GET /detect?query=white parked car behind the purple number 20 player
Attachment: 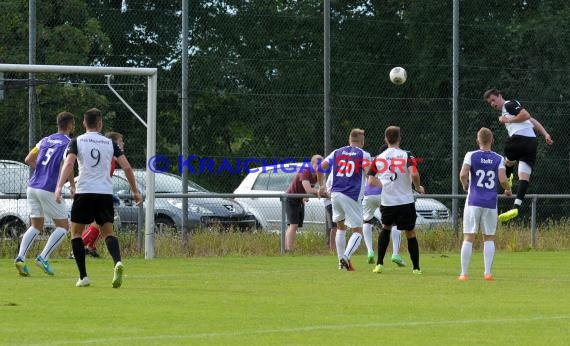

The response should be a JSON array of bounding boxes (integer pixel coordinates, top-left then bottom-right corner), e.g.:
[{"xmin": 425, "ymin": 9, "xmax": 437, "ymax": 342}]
[{"xmin": 234, "ymin": 163, "xmax": 451, "ymax": 231}]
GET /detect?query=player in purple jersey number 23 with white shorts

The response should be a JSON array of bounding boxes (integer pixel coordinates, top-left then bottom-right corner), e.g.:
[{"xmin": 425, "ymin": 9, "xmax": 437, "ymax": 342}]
[{"xmin": 459, "ymin": 127, "xmax": 512, "ymax": 281}]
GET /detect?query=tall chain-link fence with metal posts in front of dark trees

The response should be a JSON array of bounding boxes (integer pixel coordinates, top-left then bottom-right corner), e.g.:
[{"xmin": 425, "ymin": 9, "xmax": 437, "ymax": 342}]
[{"xmin": 0, "ymin": 0, "xmax": 570, "ymax": 238}]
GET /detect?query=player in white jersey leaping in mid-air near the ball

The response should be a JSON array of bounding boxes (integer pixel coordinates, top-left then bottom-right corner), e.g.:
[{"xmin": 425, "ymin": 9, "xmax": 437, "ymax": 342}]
[{"xmin": 483, "ymin": 89, "xmax": 554, "ymax": 221}]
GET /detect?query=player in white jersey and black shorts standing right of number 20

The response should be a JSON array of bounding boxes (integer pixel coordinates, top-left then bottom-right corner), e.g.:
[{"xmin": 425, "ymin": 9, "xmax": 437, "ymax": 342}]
[{"xmin": 368, "ymin": 126, "xmax": 425, "ymax": 274}]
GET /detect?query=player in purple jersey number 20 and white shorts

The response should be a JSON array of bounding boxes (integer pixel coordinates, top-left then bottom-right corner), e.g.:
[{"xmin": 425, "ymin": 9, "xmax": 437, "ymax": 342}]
[{"xmin": 321, "ymin": 129, "xmax": 370, "ymax": 271}]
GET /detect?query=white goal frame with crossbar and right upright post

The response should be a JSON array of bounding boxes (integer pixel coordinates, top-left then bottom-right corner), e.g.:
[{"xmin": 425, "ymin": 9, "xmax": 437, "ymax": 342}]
[{"xmin": 0, "ymin": 64, "xmax": 158, "ymax": 259}]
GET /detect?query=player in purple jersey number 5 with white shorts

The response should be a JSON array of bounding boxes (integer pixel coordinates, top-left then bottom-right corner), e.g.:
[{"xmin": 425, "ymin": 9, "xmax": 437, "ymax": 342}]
[{"xmin": 15, "ymin": 112, "xmax": 75, "ymax": 276}]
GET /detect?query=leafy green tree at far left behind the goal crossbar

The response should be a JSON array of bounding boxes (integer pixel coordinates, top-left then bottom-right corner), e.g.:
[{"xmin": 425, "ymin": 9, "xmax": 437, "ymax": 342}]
[{"xmin": 0, "ymin": 0, "xmax": 109, "ymax": 157}]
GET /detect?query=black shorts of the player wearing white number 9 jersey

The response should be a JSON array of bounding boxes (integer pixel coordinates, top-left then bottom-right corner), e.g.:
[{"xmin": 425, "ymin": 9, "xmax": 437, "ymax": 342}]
[{"xmin": 71, "ymin": 193, "xmax": 114, "ymax": 225}]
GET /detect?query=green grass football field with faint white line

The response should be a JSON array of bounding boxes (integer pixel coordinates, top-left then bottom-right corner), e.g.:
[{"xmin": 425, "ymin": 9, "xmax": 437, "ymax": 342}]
[{"xmin": 0, "ymin": 251, "xmax": 570, "ymax": 345}]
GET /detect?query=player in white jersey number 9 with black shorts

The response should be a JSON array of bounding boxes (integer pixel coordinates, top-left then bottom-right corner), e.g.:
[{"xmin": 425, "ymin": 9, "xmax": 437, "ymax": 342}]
[{"xmin": 55, "ymin": 108, "xmax": 142, "ymax": 288}]
